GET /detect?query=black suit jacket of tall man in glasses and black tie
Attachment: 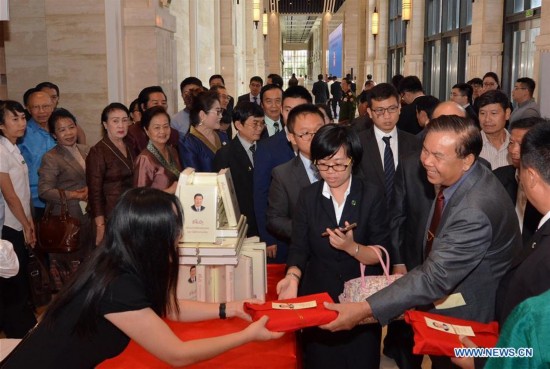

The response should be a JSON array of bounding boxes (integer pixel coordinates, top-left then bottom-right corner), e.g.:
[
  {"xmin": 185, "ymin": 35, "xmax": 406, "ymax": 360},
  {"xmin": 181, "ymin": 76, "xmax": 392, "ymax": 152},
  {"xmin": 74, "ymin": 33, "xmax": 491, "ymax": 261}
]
[{"xmin": 359, "ymin": 127, "xmax": 421, "ymax": 201}]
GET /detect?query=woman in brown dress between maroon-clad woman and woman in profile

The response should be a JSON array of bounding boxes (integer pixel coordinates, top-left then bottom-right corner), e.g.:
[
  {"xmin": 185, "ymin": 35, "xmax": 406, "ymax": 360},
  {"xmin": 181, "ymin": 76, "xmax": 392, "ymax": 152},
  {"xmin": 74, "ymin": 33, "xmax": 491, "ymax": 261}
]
[{"xmin": 134, "ymin": 106, "xmax": 182, "ymax": 194}]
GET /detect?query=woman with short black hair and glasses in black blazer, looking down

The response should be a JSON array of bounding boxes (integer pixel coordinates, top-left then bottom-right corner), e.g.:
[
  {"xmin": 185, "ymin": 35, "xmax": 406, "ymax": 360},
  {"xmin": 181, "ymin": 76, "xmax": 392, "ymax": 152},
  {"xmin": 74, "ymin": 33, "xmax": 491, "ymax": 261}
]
[{"xmin": 277, "ymin": 124, "xmax": 389, "ymax": 369}]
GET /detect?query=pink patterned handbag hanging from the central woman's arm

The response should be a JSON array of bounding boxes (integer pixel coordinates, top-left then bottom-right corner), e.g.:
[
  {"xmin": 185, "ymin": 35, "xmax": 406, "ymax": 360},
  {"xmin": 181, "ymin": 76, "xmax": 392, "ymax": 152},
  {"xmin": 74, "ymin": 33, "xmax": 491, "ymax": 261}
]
[{"xmin": 338, "ymin": 245, "xmax": 403, "ymax": 323}]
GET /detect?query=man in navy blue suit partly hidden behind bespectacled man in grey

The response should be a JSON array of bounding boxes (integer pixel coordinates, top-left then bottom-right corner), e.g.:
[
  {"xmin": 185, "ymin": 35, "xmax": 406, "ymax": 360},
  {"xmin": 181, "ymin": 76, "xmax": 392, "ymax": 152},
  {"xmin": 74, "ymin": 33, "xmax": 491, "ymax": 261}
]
[{"xmin": 253, "ymin": 86, "xmax": 313, "ymax": 263}]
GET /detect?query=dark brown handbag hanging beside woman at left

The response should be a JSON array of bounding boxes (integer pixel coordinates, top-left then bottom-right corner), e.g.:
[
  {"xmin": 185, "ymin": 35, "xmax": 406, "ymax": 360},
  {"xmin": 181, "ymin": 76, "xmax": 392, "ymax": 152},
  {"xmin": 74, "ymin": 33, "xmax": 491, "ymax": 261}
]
[{"xmin": 37, "ymin": 190, "xmax": 80, "ymax": 253}]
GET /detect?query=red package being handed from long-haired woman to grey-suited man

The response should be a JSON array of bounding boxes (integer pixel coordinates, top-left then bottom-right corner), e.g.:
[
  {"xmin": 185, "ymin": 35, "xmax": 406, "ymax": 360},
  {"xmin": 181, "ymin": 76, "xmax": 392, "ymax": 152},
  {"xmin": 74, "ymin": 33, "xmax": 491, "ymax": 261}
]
[{"xmin": 244, "ymin": 292, "xmax": 338, "ymax": 332}]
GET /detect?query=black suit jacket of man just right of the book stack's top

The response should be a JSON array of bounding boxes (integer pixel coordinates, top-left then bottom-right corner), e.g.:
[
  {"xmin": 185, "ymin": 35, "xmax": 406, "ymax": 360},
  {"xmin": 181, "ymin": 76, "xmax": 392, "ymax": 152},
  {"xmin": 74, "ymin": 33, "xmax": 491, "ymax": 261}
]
[{"xmin": 213, "ymin": 136, "xmax": 258, "ymax": 237}]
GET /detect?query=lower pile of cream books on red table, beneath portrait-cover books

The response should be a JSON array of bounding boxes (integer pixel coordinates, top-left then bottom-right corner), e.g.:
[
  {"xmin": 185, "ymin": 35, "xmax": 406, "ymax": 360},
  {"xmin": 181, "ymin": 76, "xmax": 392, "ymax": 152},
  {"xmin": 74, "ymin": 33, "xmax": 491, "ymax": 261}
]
[{"xmin": 177, "ymin": 237, "xmax": 267, "ymax": 302}]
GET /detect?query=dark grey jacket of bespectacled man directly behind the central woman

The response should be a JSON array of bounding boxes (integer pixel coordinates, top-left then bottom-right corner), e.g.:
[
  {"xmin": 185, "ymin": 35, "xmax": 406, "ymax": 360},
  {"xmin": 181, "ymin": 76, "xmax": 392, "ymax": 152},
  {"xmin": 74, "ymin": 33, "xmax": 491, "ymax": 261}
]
[{"xmin": 267, "ymin": 155, "xmax": 311, "ymax": 243}]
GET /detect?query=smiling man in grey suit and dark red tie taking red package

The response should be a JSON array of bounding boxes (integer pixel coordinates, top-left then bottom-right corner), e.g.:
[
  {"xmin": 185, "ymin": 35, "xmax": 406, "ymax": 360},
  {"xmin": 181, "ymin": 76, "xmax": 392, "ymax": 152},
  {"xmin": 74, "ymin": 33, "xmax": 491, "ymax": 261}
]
[{"xmin": 324, "ymin": 116, "xmax": 521, "ymax": 367}]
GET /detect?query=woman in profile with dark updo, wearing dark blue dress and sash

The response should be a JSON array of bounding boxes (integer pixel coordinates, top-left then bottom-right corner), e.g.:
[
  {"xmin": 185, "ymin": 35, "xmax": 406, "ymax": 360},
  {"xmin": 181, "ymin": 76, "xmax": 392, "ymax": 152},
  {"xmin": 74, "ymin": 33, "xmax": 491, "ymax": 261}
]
[{"xmin": 180, "ymin": 91, "xmax": 229, "ymax": 172}]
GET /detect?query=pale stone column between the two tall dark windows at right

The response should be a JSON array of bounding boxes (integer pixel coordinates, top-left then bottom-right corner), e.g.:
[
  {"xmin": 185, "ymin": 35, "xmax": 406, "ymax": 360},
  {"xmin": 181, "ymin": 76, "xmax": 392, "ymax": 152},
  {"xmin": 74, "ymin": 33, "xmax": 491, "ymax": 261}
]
[{"xmin": 466, "ymin": 0, "xmax": 504, "ymax": 80}]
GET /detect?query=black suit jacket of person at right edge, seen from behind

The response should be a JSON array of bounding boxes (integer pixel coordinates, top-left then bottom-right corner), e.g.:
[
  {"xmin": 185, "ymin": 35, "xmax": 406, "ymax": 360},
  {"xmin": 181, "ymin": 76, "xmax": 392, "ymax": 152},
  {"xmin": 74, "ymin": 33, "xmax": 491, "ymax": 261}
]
[{"xmin": 496, "ymin": 217, "xmax": 550, "ymax": 324}]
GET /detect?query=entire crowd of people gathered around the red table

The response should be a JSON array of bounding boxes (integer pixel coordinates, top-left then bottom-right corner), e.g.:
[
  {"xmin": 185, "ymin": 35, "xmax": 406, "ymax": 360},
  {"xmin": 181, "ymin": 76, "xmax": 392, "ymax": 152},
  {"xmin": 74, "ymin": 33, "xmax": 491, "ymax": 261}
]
[{"xmin": 0, "ymin": 68, "xmax": 550, "ymax": 369}]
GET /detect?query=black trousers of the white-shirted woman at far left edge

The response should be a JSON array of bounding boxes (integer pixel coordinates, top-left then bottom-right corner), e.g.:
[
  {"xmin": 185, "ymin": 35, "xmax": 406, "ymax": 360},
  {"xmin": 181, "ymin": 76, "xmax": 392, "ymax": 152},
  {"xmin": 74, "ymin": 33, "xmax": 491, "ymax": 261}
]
[{"xmin": 0, "ymin": 226, "xmax": 36, "ymax": 338}]
